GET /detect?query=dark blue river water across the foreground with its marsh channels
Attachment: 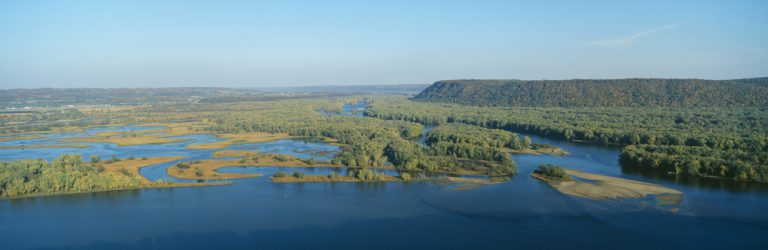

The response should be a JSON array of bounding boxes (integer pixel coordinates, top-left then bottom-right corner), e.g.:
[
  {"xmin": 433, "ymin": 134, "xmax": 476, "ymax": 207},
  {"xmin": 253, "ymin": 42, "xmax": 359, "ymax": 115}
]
[{"xmin": 0, "ymin": 126, "xmax": 768, "ymax": 249}]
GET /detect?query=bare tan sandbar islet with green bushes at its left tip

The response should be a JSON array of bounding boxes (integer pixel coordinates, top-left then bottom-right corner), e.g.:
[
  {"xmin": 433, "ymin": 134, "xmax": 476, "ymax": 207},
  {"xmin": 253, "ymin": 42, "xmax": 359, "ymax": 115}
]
[{"xmin": 532, "ymin": 170, "xmax": 683, "ymax": 201}]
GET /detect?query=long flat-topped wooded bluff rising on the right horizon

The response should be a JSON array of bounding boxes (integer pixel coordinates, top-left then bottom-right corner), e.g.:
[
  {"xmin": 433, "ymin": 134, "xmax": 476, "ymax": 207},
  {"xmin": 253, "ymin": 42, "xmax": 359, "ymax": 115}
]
[{"xmin": 413, "ymin": 77, "xmax": 768, "ymax": 107}]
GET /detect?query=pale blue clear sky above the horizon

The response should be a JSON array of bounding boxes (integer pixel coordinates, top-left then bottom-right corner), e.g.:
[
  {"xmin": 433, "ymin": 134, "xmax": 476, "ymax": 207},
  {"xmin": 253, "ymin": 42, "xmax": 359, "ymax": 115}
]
[{"xmin": 0, "ymin": 0, "xmax": 768, "ymax": 89}]
